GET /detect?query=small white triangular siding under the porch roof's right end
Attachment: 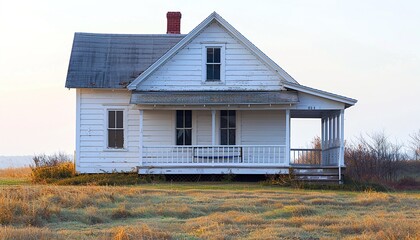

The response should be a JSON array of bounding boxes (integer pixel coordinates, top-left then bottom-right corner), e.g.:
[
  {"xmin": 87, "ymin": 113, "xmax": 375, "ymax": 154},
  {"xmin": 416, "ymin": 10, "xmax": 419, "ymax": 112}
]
[{"xmin": 296, "ymin": 92, "xmax": 344, "ymax": 109}]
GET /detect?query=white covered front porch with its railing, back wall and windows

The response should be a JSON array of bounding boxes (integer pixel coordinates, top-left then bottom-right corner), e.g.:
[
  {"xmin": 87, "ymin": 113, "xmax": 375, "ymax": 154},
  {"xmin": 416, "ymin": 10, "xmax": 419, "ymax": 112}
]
[{"xmin": 132, "ymin": 91, "xmax": 344, "ymax": 180}]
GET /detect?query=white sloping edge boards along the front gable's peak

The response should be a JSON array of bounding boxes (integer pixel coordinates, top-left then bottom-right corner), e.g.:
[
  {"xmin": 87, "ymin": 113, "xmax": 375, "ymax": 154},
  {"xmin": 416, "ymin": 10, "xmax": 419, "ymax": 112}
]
[{"xmin": 127, "ymin": 12, "xmax": 297, "ymax": 90}]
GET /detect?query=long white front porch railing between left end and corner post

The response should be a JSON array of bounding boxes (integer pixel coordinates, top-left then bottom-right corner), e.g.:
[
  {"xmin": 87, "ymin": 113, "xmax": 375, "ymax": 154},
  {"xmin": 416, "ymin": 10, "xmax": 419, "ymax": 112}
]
[{"xmin": 142, "ymin": 145, "xmax": 289, "ymax": 166}]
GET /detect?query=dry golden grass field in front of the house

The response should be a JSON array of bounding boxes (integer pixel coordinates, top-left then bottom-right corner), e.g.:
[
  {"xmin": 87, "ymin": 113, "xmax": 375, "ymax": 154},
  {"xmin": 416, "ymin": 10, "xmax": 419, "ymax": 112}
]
[{"xmin": 0, "ymin": 183, "xmax": 420, "ymax": 239}]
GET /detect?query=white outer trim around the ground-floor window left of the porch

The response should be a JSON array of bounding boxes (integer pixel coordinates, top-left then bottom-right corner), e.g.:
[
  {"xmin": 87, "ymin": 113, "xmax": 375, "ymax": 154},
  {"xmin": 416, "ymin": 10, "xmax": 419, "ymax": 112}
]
[{"xmin": 103, "ymin": 106, "xmax": 128, "ymax": 152}]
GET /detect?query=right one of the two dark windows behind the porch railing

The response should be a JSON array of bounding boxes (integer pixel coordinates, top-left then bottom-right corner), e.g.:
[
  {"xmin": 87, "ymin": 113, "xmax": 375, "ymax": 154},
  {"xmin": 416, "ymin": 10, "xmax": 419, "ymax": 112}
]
[{"xmin": 220, "ymin": 110, "xmax": 236, "ymax": 145}]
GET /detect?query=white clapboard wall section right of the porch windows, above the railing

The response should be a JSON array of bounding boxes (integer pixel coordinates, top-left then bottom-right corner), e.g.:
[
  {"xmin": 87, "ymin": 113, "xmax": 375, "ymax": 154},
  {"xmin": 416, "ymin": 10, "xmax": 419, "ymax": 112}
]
[{"xmin": 241, "ymin": 110, "xmax": 286, "ymax": 145}]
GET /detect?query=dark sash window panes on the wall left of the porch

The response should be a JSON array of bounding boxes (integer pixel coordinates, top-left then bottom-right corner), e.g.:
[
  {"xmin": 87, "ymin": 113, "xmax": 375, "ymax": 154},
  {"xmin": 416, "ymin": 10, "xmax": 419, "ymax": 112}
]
[{"xmin": 108, "ymin": 110, "xmax": 124, "ymax": 149}]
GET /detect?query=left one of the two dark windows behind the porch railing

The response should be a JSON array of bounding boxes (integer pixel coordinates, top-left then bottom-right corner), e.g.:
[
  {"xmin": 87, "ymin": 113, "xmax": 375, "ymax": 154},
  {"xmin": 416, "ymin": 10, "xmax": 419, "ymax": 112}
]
[{"xmin": 176, "ymin": 110, "xmax": 192, "ymax": 145}]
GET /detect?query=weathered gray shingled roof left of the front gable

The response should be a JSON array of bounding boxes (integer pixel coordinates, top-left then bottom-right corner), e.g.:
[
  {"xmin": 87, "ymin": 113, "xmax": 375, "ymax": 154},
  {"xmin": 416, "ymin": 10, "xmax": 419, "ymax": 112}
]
[{"xmin": 66, "ymin": 33, "xmax": 185, "ymax": 88}]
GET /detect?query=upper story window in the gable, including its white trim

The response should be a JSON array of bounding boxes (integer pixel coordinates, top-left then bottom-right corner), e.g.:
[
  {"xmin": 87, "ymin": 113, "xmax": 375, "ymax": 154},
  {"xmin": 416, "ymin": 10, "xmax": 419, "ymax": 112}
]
[{"xmin": 202, "ymin": 44, "xmax": 225, "ymax": 84}]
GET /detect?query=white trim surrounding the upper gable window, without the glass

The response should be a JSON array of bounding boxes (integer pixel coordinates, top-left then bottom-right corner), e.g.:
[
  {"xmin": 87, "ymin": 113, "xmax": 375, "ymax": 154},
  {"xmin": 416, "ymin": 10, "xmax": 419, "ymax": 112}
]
[{"xmin": 201, "ymin": 43, "xmax": 226, "ymax": 85}]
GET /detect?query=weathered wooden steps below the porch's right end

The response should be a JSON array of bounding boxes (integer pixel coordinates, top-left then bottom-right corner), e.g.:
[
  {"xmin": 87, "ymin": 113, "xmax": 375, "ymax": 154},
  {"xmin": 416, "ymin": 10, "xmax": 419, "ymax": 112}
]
[{"xmin": 291, "ymin": 165, "xmax": 344, "ymax": 184}]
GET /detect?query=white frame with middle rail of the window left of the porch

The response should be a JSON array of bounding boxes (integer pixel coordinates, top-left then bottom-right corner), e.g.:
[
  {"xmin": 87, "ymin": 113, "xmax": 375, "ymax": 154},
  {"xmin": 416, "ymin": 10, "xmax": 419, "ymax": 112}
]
[{"xmin": 104, "ymin": 107, "xmax": 128, "ymax": 152}]
